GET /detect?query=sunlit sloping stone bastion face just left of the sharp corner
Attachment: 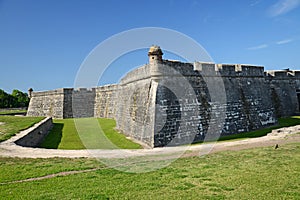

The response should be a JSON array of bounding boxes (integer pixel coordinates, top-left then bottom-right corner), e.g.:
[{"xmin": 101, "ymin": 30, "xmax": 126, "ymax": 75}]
[{"xmin": 116, "ymin": 65, "xmax": 157, "ymax": 147}]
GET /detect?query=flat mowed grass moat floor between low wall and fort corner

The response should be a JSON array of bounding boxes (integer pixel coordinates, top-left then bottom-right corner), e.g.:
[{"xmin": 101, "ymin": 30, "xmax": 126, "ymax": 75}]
[{"xmin": 40, "ymin": 118, "xmax": 142, "ymax": 149}]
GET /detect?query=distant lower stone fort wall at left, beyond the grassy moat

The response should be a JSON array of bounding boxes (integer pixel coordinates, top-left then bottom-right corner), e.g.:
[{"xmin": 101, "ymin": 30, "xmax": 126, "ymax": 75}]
[{"xmin": 27, "ymin": 85, "xmax": 118, "ymax": 118}]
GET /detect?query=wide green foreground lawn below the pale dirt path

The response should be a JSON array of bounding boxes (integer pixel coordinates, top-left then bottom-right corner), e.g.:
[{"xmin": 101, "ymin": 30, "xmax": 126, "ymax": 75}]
[{"xmin": 0, "ymin": 143, "xmax": 300, "ymax": 199}]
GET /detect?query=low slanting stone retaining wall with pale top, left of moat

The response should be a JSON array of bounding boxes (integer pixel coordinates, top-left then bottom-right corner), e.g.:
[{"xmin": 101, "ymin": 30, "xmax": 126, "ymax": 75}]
[{"xmin": 14, "ymin": 117, "xmax": 53, "ymax": 147}]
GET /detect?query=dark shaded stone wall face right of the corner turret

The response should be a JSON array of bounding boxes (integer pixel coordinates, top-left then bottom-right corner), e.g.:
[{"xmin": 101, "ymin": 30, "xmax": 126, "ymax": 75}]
[{"xmin": 154, "ymin": 61, "xmax": 276, "ymax": 147}]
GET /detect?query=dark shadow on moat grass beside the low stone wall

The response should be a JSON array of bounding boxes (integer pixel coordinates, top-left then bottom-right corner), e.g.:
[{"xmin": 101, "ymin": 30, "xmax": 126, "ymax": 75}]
[{"xmin": 39, "ymin": 123, "xmax": 64, "ymax": 149}]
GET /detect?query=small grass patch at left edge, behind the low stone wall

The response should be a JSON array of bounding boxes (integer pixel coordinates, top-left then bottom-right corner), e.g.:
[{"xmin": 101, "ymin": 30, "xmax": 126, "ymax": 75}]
[{"xmin": 0, "ymin": 115, "xmax": 44, "ymax": 142}]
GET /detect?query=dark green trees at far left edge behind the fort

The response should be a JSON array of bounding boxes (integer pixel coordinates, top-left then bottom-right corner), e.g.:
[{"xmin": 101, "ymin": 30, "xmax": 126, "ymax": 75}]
[{"xmin": 0, "ymin": 89, "xmax": 29, "ymax": 108}]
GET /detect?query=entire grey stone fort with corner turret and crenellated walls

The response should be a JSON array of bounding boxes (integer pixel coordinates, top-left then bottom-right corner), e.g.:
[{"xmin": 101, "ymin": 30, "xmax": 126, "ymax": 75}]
[{"xmin": 27, "ymin": 46, "xmax": 300, "ymax": 147}]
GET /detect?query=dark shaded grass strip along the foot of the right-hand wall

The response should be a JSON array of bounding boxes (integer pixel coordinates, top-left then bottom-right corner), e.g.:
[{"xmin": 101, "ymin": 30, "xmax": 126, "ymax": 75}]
[{"xmin": 194, "ymin": 116, "xmax": 300, "ymax": 144}]
